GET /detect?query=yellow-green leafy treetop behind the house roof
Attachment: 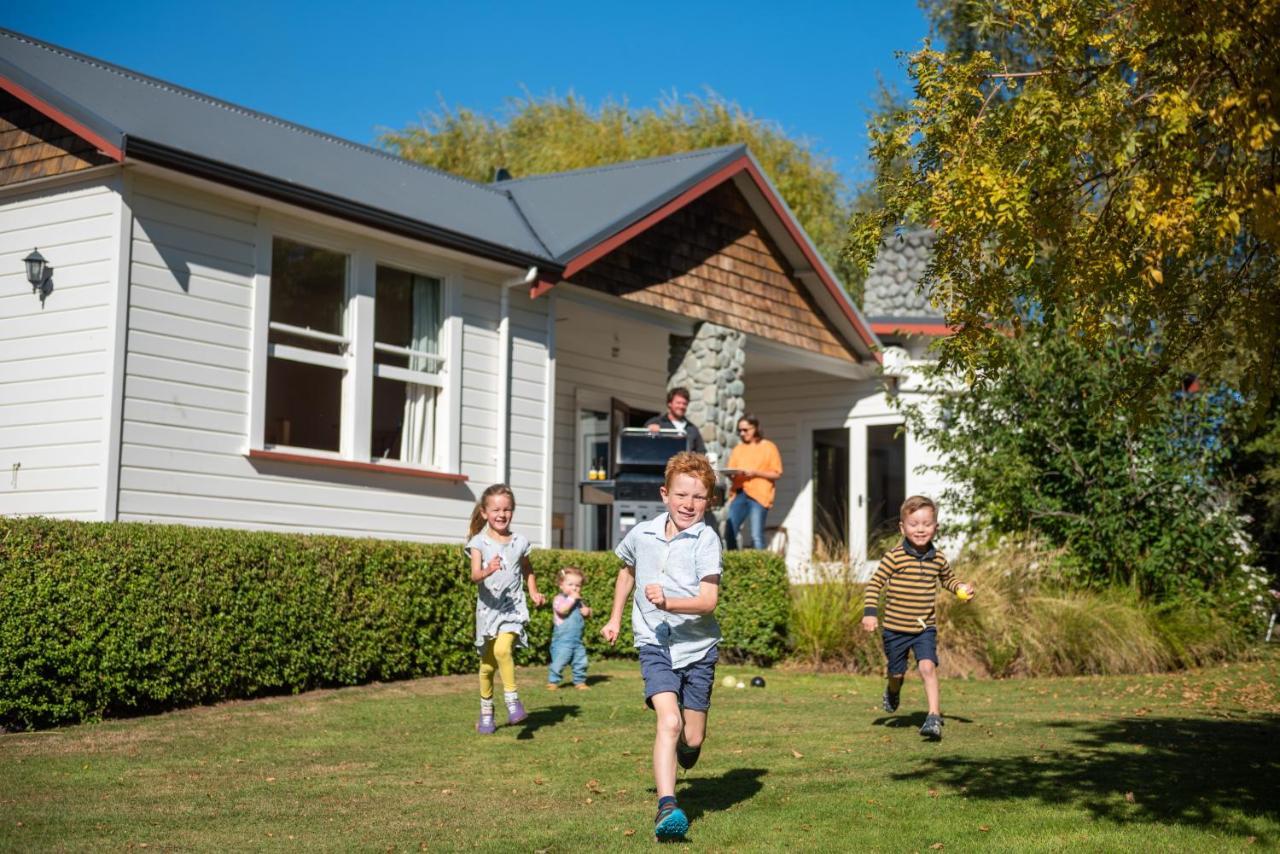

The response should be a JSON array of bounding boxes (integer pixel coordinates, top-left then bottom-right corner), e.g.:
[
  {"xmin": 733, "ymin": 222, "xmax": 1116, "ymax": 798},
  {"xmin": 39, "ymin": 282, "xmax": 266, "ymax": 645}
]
[{"xmin": 379, "ymin": 95, "xmax": 861, "ymax": 300}]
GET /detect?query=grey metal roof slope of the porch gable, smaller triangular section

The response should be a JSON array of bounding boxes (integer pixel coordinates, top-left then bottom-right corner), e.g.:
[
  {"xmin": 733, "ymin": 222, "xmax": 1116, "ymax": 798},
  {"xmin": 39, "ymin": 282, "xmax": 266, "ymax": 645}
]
[{"xmin": 493, "ymin": 145, "xmax": 746, "ymax": 264}]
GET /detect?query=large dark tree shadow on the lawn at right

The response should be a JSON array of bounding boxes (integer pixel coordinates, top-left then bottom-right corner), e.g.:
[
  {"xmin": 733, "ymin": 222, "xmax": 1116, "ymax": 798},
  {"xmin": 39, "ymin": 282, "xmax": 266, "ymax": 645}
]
[{"xmin": 893, "ymin": 714, "xmax": 1280, "ymax": 834}]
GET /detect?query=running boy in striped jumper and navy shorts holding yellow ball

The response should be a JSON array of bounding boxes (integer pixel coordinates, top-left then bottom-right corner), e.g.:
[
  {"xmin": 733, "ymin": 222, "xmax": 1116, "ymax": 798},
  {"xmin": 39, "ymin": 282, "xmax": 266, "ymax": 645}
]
[{"xmin": 863, "ymin": 495, "xmax": 974, "ymax": 740}]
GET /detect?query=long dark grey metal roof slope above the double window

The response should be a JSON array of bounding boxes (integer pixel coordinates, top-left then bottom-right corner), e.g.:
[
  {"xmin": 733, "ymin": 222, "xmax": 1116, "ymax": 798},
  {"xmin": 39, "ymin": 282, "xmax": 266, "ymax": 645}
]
[{"xmin": 0, "ymin": 29, "xmax": 552, "ymax": 262}]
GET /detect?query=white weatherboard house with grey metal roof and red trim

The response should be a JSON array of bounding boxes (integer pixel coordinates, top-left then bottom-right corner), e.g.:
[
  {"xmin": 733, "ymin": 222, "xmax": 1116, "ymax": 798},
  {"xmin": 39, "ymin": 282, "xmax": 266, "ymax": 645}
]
[{"xmin": 0, "ymin": 31, "xmax": 957, "ymax": 574}]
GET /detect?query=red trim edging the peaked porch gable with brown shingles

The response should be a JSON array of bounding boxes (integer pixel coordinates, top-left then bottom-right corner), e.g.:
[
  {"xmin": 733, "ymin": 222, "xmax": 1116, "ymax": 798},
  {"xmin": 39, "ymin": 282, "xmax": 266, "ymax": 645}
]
[{"xmin": 550, "ymin": 155, "xmax": 882, "ymax": 361}]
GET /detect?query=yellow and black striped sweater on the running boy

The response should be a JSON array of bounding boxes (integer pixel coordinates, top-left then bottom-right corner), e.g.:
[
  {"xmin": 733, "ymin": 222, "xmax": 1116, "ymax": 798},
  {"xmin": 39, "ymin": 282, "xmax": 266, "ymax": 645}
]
[{"xmin": 863, "ymin": 540, "xmax": 960, "ymax": 632}]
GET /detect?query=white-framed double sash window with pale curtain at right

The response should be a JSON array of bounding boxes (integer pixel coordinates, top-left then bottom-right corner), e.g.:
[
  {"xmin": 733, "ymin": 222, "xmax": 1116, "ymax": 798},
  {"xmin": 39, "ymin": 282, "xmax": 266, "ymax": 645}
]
[{"xmin": 262, "ymin": 237, "xmax": 447, "ymax": 466}]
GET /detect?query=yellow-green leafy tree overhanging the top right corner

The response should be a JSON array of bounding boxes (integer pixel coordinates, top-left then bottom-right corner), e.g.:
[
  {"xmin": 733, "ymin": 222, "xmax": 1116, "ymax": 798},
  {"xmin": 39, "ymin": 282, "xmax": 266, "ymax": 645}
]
[{"xmin": 849, "ymin": 0, "xmax": 1280, "ymax": 412}]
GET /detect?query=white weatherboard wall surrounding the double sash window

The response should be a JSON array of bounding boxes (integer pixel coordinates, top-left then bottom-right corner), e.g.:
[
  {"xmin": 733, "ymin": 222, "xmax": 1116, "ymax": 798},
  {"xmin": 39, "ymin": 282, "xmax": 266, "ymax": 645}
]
[{"xmin": 112, "ymin": 179, "xmax": 547, "ymax": 543}]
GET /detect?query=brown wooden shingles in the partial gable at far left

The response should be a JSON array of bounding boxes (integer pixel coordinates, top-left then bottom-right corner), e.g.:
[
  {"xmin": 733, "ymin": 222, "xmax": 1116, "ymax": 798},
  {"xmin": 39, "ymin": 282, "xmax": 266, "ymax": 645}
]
[{"xmin": 0, "ymin": 92, "xmax": 111, "ymax": 187}]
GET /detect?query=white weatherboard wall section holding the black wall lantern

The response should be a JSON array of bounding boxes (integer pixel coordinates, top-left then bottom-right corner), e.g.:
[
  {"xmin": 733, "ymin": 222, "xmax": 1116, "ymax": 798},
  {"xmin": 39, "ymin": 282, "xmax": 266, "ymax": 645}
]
[{"xmin": 0, "ymin": 183, "xmax": 120, "ymax": 519}]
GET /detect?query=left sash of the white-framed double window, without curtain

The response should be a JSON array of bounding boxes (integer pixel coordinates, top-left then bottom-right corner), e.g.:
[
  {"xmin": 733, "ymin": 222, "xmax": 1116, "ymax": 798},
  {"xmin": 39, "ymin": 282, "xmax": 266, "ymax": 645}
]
[{"xmin": 264, "ymin": 238, "xmax": 348, "ymax": 451}]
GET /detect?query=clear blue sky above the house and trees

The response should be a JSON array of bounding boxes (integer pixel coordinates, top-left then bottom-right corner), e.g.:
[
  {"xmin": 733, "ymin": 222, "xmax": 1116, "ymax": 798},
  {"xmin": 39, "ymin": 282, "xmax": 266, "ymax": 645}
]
[{"xmin": 0, "ymin": 0, "xmax": 925, "ymax": 183}]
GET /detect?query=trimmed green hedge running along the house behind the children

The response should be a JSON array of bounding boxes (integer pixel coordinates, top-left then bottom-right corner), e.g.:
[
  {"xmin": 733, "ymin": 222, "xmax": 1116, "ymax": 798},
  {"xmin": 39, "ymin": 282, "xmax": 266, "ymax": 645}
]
[{"xmin": 0, "ymin": 519, "xmax": 790, "ymax": 729}]
